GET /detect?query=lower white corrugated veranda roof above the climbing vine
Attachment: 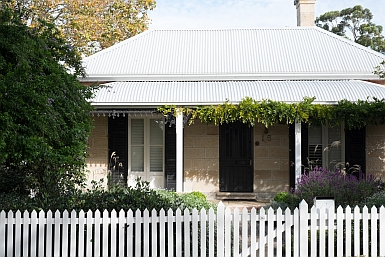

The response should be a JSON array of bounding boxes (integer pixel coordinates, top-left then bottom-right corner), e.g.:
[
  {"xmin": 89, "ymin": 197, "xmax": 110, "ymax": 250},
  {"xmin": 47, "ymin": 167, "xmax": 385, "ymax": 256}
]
[{"xmin": 92, "ymin": 80, "xmax": 385, "ymax": 108}]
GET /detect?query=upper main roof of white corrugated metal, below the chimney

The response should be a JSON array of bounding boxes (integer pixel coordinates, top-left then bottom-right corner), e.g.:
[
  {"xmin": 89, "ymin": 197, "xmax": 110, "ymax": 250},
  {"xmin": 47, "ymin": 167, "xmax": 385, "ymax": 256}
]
[{"xmin": 84, "ymin": 27, "xmax": 385, "ymax": 81}]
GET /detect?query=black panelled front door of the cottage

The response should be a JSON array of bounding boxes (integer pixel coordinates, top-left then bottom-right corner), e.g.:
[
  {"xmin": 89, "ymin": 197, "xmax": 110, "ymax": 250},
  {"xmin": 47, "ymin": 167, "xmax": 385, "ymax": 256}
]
[{"xmin": 219, "ymin": 122, "xmax": 254, "ymax": 192}]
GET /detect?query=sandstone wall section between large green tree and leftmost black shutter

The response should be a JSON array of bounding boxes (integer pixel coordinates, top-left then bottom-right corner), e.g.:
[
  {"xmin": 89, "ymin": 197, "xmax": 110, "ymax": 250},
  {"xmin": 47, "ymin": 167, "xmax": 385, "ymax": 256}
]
[{"xmin": 86, "ymin": 117, "xmax": 108, "ymax": 186}]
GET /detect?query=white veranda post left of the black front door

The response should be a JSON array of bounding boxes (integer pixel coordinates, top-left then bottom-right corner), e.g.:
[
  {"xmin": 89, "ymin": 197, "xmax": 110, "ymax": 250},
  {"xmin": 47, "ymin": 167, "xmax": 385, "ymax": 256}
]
[{"xmin": 175, "ymin": 109, "xmax": 183, "ymax": 192}]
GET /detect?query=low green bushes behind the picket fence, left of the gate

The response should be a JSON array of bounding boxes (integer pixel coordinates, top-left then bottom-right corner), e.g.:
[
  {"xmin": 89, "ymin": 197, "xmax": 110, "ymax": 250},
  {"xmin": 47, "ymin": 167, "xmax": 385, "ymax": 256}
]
[{"xmin": 0, "ymin": 179, "xmax": 216, "ymax": 212}]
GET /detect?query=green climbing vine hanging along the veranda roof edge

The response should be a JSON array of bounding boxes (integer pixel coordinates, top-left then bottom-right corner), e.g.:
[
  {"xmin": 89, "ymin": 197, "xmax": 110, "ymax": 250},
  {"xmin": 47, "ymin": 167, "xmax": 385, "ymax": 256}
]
[{"xmin": 158, "ymin": 97, "xmax": 385, "ymax": 129}]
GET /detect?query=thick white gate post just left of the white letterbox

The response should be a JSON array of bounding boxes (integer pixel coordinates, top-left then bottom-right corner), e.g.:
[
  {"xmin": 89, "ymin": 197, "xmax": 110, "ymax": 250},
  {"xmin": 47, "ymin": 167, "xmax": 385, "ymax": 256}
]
[{"xmin": 299, "ymin": 200, "xmax": 309, "ymax": 256}]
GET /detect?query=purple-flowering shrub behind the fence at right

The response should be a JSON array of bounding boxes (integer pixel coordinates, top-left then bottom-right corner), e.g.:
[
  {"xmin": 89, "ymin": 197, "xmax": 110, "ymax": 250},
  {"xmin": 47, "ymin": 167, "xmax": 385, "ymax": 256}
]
[{"xmin": 294, "ymin": 167, "xmax": 382, "ymax": 207}]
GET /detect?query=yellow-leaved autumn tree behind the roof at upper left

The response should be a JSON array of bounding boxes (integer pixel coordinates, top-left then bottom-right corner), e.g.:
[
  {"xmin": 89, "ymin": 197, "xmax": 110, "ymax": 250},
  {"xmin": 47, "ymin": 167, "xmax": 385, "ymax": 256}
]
[{"xmin": 1, "ymin": 0, "xmax": 155, "ymax": 55}]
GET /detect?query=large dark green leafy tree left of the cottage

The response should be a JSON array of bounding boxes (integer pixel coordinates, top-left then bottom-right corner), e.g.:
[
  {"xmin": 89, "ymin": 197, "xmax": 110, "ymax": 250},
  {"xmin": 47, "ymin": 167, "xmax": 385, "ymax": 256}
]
[{"xmin": 0, "ymin": 5, "xmax": 94, "ymax": 197}]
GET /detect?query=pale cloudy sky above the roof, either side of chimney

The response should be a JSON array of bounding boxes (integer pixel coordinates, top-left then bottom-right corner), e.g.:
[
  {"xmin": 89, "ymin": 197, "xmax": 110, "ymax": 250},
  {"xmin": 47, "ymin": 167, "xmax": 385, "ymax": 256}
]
[{"xmin": 148, "ymin": 0, "xmax": 385, "ymax": 29}]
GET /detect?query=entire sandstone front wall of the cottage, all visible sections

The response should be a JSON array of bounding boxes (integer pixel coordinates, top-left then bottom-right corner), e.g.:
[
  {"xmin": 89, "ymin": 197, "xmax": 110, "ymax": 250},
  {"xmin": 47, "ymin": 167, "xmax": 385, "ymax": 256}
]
[{"xmin": 87, "ymin": 117, "xmax": 385, "ymax": 199}]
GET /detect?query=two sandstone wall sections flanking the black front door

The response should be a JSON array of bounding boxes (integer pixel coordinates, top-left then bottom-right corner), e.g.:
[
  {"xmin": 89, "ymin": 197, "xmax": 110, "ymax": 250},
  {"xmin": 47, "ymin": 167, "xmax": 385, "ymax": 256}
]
[{"xmin": 184, "ymin": 121, "xmax": 289, "ymax": 199}]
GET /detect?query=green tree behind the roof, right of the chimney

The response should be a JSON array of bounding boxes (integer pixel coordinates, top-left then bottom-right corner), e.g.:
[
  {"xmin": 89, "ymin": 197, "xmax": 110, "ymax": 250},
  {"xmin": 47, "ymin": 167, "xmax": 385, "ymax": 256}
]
[{"xmin": 315, "ymin": 5, "xmax": 385, "ymax": 53}]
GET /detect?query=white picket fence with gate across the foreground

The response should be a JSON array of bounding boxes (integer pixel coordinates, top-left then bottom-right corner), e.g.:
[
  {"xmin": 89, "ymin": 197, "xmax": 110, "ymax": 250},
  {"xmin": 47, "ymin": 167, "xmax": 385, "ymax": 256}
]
[{"xmin": 0, "ymin": 201, "xmax": 385, "ymax": 257}]
